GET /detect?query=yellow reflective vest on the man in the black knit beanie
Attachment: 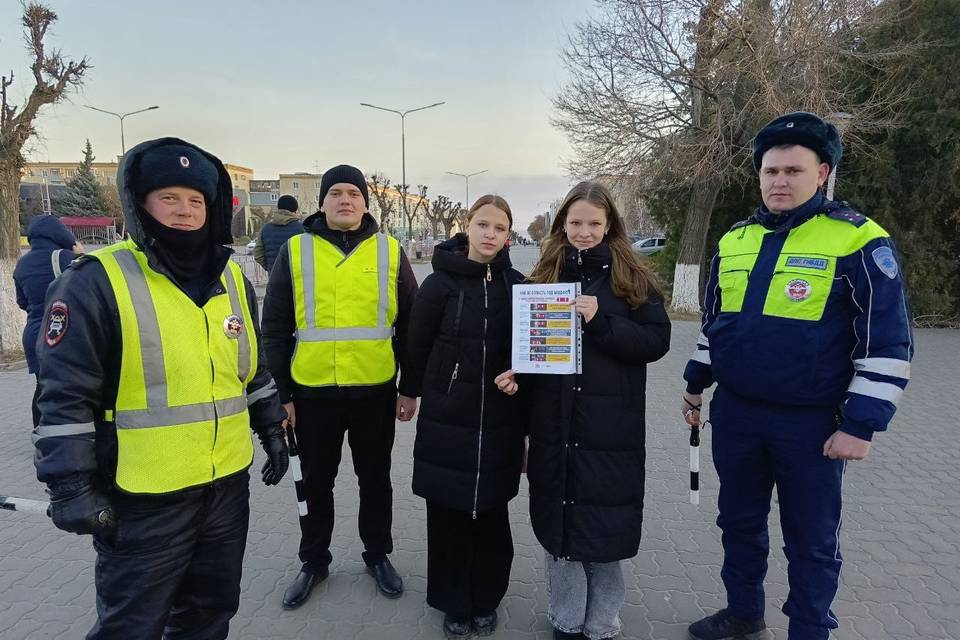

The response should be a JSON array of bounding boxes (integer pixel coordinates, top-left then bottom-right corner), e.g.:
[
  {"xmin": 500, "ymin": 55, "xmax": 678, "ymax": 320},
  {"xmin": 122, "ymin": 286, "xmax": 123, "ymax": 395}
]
[{"xmin": 287, "ymin": 233, "xmax": 400, "ymax": 387}]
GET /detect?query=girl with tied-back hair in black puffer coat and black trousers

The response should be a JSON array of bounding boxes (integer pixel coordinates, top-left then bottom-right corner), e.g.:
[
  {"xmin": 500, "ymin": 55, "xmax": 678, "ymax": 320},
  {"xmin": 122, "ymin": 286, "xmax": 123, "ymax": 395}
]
[{"xmin": 408, "ymin": 195, "xmax": 523, "ymax": 637}]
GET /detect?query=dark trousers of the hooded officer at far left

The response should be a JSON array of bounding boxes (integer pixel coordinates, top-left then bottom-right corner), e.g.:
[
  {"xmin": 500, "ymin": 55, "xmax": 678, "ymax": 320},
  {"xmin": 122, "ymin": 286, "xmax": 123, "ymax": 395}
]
[{"xmin": 87, "ymin": 471, "xmax": 250, "ymax": 640}]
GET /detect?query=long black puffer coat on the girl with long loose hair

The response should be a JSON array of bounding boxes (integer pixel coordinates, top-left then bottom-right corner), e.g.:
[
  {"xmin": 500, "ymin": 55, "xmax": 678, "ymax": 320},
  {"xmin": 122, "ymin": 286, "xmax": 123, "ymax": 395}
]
[{"xmin": 520, "ymin": 243, "xmax": 670, "ymax": 562}]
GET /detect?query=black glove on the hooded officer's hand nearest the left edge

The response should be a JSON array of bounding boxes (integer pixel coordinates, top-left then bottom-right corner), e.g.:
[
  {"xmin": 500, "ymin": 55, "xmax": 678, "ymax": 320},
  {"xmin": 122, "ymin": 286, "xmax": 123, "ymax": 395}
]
[{"xmin": 47, "ymin": 476, "xmax": 116, "ymax": 535}]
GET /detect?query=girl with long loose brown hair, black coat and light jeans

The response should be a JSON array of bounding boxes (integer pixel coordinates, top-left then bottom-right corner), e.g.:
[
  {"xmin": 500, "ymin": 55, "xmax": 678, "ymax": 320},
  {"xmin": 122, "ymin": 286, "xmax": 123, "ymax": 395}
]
[{"xmin": 497, "ymin": 182, "xmax": 670, "ymax": 640}]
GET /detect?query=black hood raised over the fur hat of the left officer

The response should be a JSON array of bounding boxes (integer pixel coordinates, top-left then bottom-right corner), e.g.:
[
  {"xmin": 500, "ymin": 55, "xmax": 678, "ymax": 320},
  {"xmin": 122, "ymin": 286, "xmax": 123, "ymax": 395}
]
[{"xmin": 117, "ymin": 138, "xmax": 233, "ymax": 247}]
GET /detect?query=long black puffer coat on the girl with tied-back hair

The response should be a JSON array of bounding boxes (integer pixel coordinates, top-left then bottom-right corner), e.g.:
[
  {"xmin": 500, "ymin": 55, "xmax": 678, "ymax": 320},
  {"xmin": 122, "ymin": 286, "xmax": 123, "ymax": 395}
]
[{"xmin": 408, "ymin": 234, "xmax": 523, "ymax": 513}]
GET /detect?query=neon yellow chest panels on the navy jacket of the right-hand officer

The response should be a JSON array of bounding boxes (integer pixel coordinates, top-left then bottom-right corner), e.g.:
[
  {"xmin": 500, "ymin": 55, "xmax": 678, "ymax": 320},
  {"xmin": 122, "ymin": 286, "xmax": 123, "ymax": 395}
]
[{"xmin": 717, "ymin": 214, "xmax": 889, "ymax": 321}]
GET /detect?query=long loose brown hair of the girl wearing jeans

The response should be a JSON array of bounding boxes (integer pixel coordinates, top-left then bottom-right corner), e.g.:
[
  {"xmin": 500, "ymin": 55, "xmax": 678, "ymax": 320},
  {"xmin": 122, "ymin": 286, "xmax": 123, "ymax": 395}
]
[{"xmin": 530, "ymin": 181, "xmax": 662, "ymax": 307}]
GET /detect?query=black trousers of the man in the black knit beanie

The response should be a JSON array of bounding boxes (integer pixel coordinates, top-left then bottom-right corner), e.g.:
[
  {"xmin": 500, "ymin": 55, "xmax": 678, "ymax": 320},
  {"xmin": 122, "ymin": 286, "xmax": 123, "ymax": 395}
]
[{"xmin": 294, "ymin": 391, "xmax": 397, "ymax": 573}]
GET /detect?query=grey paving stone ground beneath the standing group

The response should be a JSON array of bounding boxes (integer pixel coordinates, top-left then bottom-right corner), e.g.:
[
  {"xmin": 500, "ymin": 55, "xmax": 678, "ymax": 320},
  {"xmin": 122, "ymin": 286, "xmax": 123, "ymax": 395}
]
[{"xmin": 0, "ymin": 249, "xmax": 960, "ymax": 640}]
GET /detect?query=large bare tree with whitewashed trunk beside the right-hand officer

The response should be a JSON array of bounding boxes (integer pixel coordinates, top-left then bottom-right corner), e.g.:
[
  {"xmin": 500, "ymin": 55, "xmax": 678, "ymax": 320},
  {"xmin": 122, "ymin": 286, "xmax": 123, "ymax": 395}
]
[{"xmin": 554, "ymin": 0, "xmax": 904, "ymax": 311}]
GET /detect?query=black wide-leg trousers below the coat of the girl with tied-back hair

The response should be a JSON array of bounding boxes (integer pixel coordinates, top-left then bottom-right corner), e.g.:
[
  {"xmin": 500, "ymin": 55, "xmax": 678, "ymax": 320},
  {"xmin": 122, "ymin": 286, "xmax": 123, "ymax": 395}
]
[{"xmin": 427, "ymin": 502, "xmax": 513, "ymax": 620}]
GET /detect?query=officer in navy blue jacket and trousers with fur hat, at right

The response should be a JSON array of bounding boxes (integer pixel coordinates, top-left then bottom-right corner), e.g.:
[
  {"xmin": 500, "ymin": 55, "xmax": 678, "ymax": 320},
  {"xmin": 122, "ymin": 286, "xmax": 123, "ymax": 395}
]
[{"xmin": 681, "ymin": 112, "xmax": 913, "ymax": 640}]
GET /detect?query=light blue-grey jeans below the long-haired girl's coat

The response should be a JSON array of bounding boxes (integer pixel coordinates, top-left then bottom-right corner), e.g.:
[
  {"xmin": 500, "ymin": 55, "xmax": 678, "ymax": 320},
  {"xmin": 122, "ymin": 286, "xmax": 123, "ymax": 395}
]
[{"xmin": 545, "ymin": 553, "xmax": 626, "ymax": 640}]
